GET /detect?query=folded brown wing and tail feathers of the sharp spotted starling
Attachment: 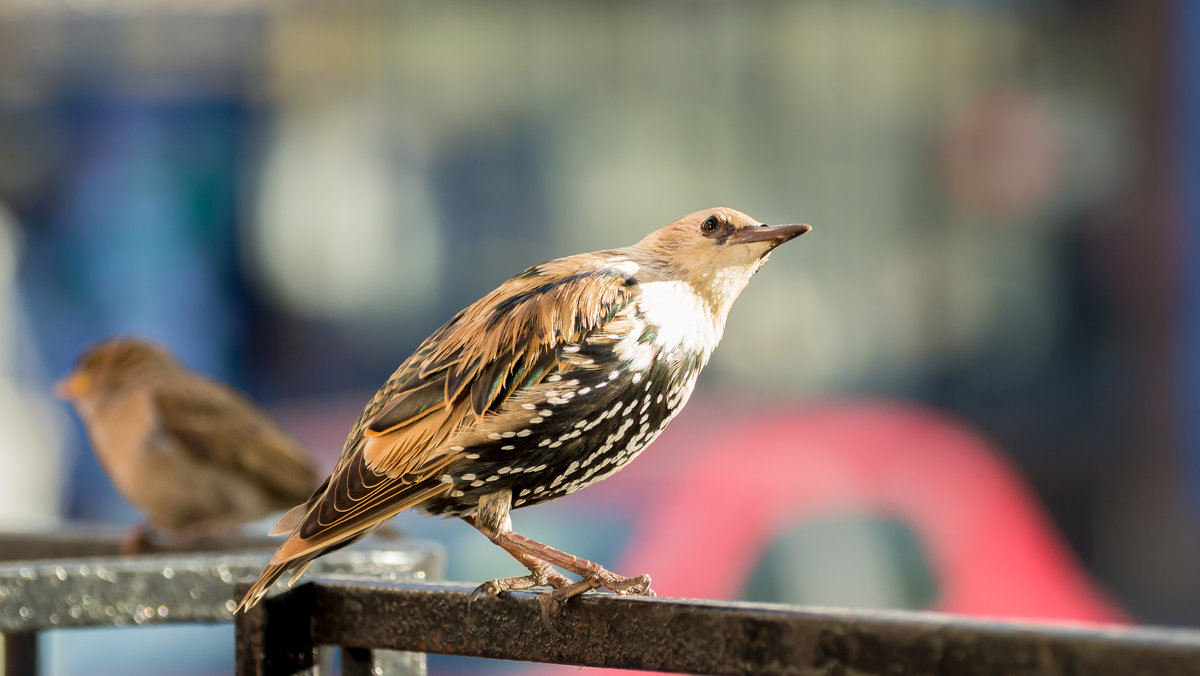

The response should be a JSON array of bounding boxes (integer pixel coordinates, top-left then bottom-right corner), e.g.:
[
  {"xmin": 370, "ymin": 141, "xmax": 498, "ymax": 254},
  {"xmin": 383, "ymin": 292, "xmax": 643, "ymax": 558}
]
[{"xmin": 242, "ymin": 255, "xmax": 637, "ymax": 605}]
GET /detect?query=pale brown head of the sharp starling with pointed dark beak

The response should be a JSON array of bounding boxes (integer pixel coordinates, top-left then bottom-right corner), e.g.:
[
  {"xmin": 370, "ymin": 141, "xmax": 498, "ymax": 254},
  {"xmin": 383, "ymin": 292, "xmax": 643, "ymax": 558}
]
[{"xmin": 632, "ymin": 207, "xmax": 811, "ymax": 313}]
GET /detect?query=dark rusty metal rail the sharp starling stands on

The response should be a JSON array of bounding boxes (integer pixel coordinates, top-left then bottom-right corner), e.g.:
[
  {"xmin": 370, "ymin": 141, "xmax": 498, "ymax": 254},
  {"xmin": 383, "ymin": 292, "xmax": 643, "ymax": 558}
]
[{"xmin": 236, "ymin": 576, "xmax": 1200, "ymax": 676}]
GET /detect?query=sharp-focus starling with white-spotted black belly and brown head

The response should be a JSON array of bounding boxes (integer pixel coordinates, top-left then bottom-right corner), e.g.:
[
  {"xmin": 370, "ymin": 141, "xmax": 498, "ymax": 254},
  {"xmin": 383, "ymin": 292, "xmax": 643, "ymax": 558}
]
[{"xmin": 239, "ymin": 208, "xmax": 809, "ymax": 610}]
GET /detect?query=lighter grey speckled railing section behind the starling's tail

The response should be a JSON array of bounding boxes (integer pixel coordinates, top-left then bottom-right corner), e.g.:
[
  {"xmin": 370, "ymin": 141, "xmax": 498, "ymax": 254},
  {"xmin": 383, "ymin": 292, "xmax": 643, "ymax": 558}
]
[{"xmin": 0, "ymin": 533, "xmax": 442, "ymax": 676}]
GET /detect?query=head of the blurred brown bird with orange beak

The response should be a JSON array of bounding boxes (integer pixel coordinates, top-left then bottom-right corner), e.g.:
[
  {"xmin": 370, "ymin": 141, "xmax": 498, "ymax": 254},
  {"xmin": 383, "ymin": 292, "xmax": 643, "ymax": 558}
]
[{"xmin": 54, "ymin": 337, "xmax": 179, "ymax": 407}]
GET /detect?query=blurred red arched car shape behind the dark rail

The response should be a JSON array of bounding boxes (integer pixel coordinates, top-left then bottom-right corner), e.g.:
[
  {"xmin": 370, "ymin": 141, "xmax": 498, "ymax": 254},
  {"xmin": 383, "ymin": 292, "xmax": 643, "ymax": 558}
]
[{"xmin": 617, "ymin": 402, "xmax": 1127, "ymax": 622}]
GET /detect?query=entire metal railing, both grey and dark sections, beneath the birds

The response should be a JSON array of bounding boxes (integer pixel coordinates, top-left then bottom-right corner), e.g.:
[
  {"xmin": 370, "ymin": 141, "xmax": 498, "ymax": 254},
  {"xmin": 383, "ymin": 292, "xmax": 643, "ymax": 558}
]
[{"xmin": 0, "ymin": 534, "xmax": 1200, "ymax": 676}]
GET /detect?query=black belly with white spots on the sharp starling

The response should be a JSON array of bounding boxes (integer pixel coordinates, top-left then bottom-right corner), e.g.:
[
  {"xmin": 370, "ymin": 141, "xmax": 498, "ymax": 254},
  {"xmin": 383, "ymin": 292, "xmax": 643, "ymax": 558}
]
[{"xmin": 424, "ymin": 316, "xmax": 707, "ymax": 515}]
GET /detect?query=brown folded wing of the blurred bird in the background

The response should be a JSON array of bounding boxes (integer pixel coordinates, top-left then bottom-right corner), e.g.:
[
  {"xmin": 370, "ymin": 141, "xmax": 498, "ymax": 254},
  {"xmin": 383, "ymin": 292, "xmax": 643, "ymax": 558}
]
[{"xmin": 152, "ymin": 376, "xmax": 317, "ymax": 507}]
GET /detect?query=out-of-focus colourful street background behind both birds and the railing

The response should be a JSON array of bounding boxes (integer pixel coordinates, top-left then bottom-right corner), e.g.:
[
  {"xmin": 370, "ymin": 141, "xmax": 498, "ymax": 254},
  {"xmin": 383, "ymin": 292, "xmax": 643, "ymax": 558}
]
[{"xmin": 0, "ymin": 0, "xmax": 1200, "ymax": 674}]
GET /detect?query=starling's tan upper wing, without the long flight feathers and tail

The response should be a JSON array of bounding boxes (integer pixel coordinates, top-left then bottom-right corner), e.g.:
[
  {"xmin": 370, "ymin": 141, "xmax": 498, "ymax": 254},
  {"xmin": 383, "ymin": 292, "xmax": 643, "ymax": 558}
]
[{"xmin": 347, "ymin": 264, "xmax": 636, "ymax": 474}]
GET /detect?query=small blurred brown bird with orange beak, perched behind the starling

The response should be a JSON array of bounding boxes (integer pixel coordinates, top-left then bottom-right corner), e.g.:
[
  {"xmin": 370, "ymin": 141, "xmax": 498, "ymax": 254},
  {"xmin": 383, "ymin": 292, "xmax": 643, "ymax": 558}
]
[{"xmin": 56, "ymin": 337, "xmax": 317, "ymax": 551}]
